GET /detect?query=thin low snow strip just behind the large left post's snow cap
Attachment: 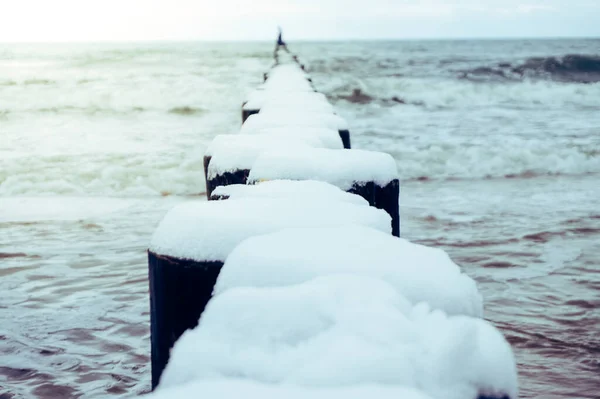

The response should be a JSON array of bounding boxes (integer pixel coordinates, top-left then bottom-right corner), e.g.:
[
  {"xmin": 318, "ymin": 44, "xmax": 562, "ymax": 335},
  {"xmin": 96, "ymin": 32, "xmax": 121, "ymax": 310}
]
[{"xmin": 212, "ymin": 180, "xmax": 369, "ymax": 205}]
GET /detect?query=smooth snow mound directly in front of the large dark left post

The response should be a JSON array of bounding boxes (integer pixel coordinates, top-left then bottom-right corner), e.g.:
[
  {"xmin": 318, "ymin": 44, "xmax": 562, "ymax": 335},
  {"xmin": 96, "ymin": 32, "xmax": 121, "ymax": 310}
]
[{"xmin": 215, "ymin": 226, "xmax": 483, "ymax": 317}]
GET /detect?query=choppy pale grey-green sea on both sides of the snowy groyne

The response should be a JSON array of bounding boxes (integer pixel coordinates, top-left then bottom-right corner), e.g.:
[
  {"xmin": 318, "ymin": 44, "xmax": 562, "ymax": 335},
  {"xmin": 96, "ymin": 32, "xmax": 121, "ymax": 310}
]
[{"xmin": 0, "ymin": 39, "xmax": 600, "ymax": 399}]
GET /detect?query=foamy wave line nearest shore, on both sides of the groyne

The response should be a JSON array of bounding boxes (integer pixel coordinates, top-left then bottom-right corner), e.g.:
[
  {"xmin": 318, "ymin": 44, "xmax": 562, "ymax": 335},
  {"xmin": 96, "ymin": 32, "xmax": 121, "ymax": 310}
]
[{"xmin": 0, "ymin": 138, "xmax": 600, "ymax": 197}]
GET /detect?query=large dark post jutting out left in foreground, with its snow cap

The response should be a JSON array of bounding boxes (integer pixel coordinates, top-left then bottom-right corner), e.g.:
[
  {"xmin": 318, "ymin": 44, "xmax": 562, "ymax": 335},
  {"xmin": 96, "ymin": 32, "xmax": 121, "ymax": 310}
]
[{"xmin": 148, "ymin": 198, "xmax": 390, "ymax": 388}]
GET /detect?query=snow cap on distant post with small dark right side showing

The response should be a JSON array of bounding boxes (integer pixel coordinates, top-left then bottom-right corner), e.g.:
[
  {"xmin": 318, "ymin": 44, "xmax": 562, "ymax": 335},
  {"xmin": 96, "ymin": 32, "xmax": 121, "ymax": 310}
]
[{"xmin": 242, "ymin": 109, "xmax": 348, "ymax": 130}]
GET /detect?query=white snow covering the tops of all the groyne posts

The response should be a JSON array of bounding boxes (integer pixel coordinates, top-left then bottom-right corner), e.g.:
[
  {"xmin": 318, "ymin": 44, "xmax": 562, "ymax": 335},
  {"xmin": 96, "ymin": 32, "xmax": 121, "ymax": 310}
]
[{"xmin": 144, "ymin": 58, "xmax": 518, "ymax": 399}]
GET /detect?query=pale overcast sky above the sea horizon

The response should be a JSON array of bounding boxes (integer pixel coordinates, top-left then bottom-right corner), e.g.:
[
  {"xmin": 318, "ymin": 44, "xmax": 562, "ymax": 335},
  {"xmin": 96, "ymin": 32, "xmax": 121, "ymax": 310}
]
[{"xmin": 0, "ymin": 0, "xmax": 600, "ymax": 42}]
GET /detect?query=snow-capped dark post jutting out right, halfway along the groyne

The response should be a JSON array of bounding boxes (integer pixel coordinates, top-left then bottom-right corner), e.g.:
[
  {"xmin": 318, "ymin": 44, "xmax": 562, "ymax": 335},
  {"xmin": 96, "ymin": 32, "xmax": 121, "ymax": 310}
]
[{"xmin": 247, "ymin": 148, "xmax": 400, "ymax": 237}]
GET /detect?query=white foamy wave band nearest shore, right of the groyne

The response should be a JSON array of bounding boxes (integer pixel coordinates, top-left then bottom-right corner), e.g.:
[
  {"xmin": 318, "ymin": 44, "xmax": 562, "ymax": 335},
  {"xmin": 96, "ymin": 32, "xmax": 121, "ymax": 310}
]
[{"xmin": 369, "ymin": 137, "xmax": 600, "ymax": 181}]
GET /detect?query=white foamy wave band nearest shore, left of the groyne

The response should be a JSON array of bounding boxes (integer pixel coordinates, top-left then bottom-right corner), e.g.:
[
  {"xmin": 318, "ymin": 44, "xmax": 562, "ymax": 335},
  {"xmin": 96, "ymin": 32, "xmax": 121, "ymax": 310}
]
[{"xmin": 0, "ymin": 153, "xmax": 205, "ymax": 197}]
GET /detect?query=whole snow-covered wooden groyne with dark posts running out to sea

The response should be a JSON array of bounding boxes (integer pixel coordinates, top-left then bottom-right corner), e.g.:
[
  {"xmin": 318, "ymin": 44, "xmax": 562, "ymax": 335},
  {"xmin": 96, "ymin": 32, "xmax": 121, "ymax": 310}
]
[{"xmin": 148, "ymin": 46, "xmax": 517, "ymax": 399}]
